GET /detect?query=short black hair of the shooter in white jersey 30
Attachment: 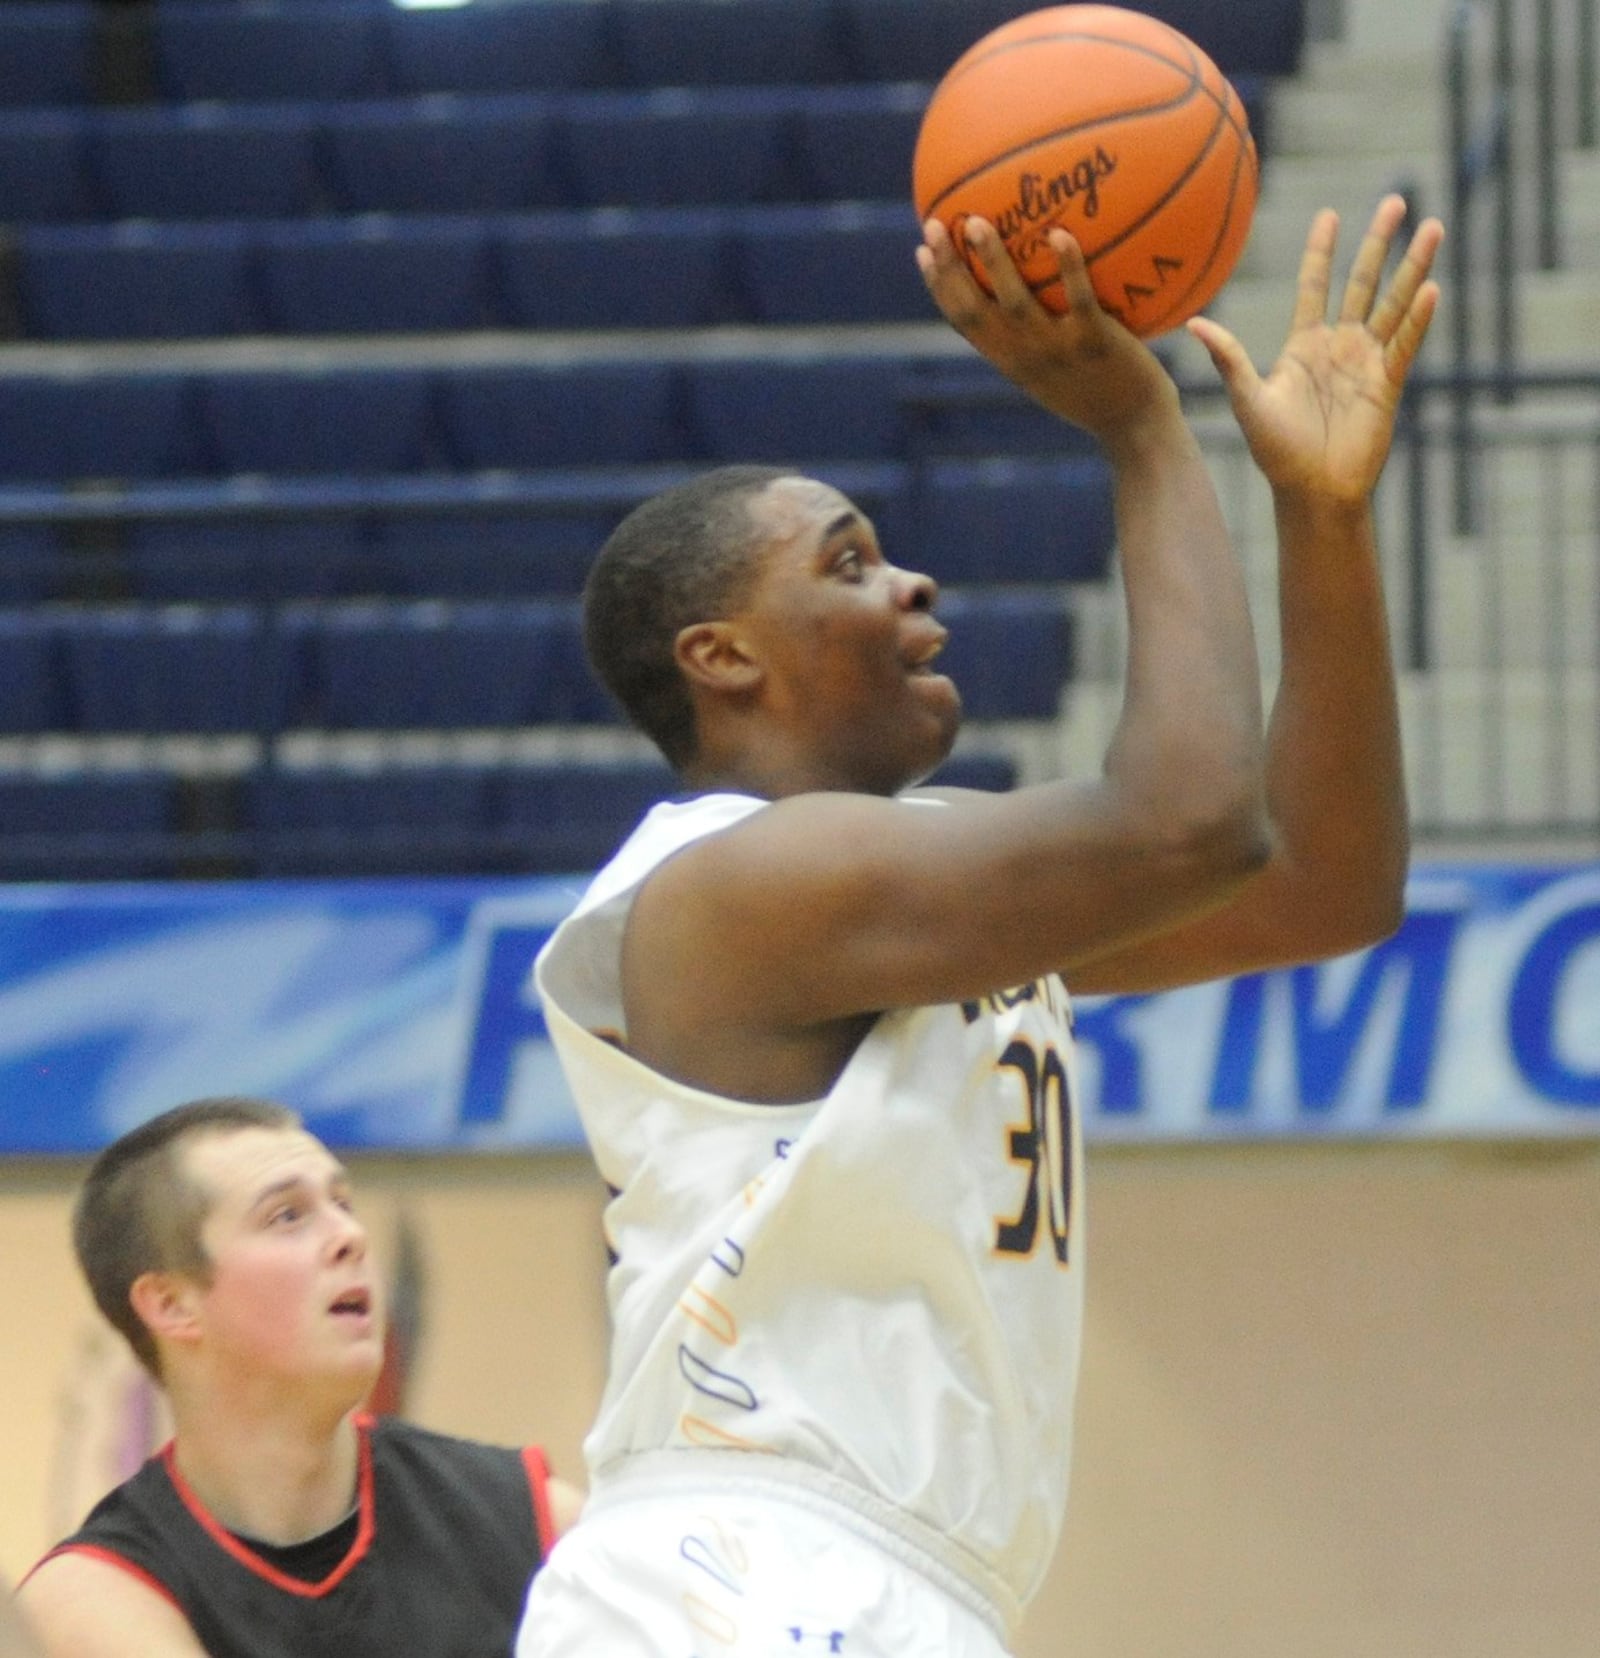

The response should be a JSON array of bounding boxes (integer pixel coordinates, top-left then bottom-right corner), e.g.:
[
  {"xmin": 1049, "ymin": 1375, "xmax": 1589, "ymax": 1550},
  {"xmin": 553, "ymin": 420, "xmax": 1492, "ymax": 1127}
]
[{"xmin": 584, "ymin": 466, "xmax": 798, "ymax": 769}]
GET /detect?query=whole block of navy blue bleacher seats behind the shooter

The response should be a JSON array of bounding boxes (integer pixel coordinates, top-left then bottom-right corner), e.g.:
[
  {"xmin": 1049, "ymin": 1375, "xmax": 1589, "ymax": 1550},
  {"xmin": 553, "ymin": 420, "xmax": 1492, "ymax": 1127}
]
[{"xmin": 0, "ymin": 0, "xmax": 1303, "ymax": 877}]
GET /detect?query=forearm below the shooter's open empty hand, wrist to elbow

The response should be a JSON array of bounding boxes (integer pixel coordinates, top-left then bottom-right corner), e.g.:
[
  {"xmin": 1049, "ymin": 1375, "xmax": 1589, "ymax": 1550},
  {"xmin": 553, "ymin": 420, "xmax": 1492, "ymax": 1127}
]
[{"xmin": 1267, "ymin": 496, "xmax": 1409, "ymax": 953}]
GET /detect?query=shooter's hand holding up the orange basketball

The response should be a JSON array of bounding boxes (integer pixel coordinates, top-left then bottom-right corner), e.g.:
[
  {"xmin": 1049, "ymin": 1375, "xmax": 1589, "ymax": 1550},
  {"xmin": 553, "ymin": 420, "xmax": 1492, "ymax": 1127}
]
[{"xmin": 917, "ymin": 219, "xmax": 1177, "ymax": 441}]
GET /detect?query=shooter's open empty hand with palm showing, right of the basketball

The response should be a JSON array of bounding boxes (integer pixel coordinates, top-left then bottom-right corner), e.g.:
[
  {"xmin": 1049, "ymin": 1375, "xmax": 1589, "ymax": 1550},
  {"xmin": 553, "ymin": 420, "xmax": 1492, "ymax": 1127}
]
[{"xmin": 1189, "ymin": 196, "xmax": 1444, "ymax": 504}]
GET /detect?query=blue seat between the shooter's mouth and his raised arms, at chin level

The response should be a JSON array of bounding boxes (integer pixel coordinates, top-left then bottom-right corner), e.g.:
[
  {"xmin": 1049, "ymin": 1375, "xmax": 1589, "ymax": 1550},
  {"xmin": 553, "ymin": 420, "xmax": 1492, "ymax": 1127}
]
[{"xmin": 938, "ymin": 589, "xmax": 1073, "ymax": 720}]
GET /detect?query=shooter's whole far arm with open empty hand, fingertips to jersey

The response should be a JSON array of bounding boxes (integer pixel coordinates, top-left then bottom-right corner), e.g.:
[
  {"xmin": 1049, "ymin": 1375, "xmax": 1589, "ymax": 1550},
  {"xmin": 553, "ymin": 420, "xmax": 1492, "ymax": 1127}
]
[{"xmin": 1073, "ymin": 197, "xmax": 1442, "ymax": 991}]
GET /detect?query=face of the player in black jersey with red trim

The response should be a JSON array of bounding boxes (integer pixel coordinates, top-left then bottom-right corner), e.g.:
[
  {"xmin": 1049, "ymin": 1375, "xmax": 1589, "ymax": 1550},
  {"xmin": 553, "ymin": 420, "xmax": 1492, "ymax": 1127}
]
[{"xmin": 186, "ymin": 1127, "xmax": 383, "ymax": 1393}]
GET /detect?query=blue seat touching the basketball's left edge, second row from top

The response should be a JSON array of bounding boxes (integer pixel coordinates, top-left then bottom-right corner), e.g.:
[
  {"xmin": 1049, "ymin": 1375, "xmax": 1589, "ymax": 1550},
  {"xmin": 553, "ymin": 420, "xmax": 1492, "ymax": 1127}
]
[{"xmin": 796, "ymin": 81, "xmax": 930, "ymax": 201}]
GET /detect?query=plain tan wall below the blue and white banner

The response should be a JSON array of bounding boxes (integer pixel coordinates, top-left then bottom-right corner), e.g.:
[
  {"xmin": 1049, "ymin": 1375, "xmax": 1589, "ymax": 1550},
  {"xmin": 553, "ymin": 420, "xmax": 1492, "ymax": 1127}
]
[{"xmin": 0, "ymin": 1146, "xmax": 1600, "ymax": 1658}]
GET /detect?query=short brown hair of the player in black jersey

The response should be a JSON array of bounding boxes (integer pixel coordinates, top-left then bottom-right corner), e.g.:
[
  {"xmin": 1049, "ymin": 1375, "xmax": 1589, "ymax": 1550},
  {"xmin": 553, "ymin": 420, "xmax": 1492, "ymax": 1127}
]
[{"xmin": 73, "ymin": 1098, "xmax": 302, "ymax": 1381}]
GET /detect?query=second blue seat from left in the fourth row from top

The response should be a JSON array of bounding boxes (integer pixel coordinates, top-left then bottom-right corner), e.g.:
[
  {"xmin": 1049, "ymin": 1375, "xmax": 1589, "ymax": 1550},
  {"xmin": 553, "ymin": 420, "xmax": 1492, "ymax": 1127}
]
[{"xmin": 197, "ymin": 366, "xmax": 438, "ymax": 474}]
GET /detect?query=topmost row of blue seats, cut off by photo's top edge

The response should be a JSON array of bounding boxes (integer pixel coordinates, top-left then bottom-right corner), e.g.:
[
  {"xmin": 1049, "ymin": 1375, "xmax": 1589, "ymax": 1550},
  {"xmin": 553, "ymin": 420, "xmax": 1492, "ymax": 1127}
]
[{"xmin": 0, "ymin": 0, "xmax": 1305, "ymax": 104}]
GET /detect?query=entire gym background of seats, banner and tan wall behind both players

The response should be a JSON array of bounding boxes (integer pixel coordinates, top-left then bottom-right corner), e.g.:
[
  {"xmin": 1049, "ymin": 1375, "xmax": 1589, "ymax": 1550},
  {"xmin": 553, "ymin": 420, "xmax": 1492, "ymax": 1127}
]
[{"xmin": 0, "ymin": 0, "xmax": 1600, "ymax": 1658}]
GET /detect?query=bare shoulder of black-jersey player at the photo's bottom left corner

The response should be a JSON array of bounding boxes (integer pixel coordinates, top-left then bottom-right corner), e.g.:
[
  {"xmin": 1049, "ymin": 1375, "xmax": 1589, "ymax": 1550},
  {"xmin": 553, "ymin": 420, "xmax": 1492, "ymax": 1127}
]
[{"xmin": 17, "ymin": 1549, "xmax": 206, "ymax": 1658}]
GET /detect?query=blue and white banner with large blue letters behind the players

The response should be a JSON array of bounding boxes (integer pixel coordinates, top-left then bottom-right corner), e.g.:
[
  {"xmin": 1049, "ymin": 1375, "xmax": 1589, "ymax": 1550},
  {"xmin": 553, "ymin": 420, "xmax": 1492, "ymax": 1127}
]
[{"xmin": 0, "ymin": 865, "xmax": 1600, "ymax": 1154}]
